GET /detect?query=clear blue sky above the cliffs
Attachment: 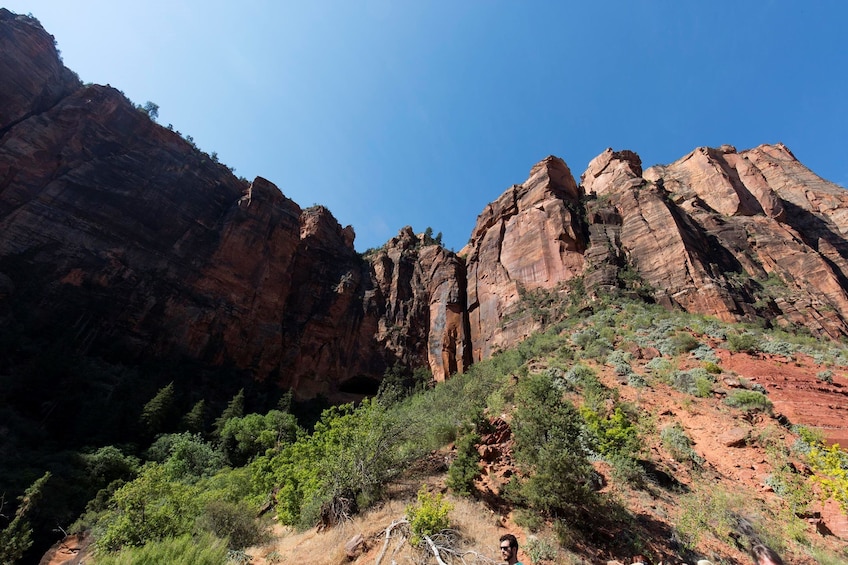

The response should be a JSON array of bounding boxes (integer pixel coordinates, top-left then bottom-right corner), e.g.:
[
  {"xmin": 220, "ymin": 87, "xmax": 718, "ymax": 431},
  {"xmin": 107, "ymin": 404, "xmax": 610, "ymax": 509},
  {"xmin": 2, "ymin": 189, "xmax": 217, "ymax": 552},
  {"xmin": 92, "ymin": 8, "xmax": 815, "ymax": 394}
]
[{"xmin": 8, "ymin": 0, "xmax": 848, "ymax": 251}]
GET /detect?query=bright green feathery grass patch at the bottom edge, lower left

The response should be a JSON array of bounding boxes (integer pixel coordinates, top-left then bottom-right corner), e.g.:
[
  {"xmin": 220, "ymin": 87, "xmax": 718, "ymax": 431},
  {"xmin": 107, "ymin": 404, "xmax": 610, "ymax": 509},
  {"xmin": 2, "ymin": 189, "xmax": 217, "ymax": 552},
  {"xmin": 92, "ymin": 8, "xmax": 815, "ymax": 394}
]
[{"xmin": 96, "ymin": 533, "xmax": 227, "ymax": 565}]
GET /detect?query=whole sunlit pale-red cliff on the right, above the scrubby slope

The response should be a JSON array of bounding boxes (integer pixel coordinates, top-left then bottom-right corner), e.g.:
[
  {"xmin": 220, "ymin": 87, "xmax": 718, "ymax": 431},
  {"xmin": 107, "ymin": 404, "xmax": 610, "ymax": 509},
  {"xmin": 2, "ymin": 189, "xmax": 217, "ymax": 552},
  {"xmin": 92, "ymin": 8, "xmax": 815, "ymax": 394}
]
[{"xmin": 468, "ymin": 145, "xmax": 848, "ymax": 346}]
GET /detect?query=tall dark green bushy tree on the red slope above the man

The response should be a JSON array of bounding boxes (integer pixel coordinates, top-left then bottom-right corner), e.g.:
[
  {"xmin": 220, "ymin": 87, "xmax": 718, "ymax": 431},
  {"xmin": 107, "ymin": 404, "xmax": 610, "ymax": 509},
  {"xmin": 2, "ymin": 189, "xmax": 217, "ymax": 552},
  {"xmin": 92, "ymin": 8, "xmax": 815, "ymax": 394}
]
[{"xmin": 513, "ymin": 375, "xmax": 594, "ymax": 516}]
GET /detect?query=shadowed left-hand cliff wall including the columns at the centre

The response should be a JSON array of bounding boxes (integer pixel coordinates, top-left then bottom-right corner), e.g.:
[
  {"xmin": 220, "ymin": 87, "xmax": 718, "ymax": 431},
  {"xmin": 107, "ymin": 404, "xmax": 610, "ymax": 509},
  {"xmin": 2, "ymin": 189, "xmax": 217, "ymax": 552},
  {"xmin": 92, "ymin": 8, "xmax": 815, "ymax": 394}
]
[{"xmin": 0, "ymin": 10, "xmax": 468, "ymax": 398}]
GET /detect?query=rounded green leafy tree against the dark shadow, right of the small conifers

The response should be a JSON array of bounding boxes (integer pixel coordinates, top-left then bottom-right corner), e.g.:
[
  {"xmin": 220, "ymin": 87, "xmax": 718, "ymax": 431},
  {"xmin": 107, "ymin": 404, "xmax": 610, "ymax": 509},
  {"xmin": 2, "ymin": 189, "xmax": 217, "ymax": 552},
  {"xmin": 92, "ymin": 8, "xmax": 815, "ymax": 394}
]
[{"xmin": 221, "ymin": 410, "xmax": 298, "ymax": 466}]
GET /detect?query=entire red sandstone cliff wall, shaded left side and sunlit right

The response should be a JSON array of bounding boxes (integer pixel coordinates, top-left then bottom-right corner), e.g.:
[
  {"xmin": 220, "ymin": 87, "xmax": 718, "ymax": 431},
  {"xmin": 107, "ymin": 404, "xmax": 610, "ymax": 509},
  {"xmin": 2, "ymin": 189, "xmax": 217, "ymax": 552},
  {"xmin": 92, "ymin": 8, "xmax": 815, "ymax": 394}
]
[{"xmin": 0, "ymin": 10, "xmax": 848, "ymax": 399}]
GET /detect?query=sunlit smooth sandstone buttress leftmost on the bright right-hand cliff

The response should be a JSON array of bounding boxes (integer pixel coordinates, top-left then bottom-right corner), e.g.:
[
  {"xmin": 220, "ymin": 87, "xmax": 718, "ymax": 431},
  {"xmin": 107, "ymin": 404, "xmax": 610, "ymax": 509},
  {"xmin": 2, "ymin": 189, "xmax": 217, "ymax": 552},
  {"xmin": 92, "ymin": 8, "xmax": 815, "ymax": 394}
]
[{"xmin": 462, "ymin": 157, "xmax": 586, "ymax": 360}]
